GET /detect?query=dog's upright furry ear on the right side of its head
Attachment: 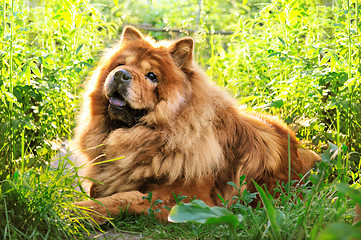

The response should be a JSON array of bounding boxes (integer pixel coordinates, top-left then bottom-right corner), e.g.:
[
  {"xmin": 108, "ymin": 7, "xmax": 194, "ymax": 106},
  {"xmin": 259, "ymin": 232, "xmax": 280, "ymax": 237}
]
[{"xmin": 170, "ymin": 38, "xmax": 193, "ymax": 67}]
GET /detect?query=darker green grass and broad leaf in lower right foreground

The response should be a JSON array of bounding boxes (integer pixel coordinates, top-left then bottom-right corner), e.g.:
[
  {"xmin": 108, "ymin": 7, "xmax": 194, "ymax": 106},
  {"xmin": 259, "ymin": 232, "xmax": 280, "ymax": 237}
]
[{"xmin": 170, "ymin": 152, "xmax": 359, "ymax": 239}]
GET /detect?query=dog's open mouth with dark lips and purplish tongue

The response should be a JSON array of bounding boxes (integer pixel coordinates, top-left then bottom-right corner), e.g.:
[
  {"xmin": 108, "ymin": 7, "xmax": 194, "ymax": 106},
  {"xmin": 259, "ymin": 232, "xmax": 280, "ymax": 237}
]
[{"xmin": 107, "ymin": 95, "xmax": 148, "ymax": 127}]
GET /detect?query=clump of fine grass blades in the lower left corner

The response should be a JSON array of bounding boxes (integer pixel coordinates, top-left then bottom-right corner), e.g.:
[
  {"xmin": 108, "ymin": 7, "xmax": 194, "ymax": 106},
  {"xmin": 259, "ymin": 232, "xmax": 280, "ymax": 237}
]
[{"xmin": 0, "ymin": 158, "xmax": 86, "ymax": 239}]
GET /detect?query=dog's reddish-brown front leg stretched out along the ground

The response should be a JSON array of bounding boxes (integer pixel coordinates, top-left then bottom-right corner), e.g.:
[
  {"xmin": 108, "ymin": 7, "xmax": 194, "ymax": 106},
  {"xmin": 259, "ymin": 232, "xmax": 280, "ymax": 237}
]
[{"xmin": 71, "ymin": 179, "xmax": 216, "ymax": 224}]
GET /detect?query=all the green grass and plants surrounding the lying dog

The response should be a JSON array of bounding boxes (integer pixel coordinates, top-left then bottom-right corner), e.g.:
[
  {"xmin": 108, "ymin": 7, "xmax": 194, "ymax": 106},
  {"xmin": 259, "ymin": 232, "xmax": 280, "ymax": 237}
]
[{"xmin": 0, "ymin": 0, "xmax": 361, "ymax": 239}]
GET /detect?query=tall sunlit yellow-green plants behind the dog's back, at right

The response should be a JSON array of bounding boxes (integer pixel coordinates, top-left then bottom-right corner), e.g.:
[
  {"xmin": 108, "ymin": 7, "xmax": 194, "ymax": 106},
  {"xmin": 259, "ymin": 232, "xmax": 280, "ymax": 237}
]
[{"xmin": 205, "ymin": 1, "xmax": 361, "ymax": 158}]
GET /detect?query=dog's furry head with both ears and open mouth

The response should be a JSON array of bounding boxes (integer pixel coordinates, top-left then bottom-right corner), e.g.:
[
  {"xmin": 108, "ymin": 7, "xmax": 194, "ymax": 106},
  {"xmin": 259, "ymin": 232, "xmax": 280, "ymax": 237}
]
[{"xmin": 97, "ymin": 27, "xmax": 193, "ymax": 127}]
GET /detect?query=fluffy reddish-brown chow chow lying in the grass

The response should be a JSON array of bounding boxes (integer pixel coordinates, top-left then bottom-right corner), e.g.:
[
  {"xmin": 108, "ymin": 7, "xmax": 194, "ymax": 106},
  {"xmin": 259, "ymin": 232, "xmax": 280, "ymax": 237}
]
[{"xmin": 75, "ymin": 27, "xmax": 319, "ymax": 224}]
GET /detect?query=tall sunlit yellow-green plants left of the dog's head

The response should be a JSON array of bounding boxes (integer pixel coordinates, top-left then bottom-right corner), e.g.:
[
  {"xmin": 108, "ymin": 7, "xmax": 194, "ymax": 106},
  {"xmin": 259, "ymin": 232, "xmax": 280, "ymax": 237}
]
[{"xmin": 0, "ymin": 1, "xmax": 115, "ymax": 179}]
